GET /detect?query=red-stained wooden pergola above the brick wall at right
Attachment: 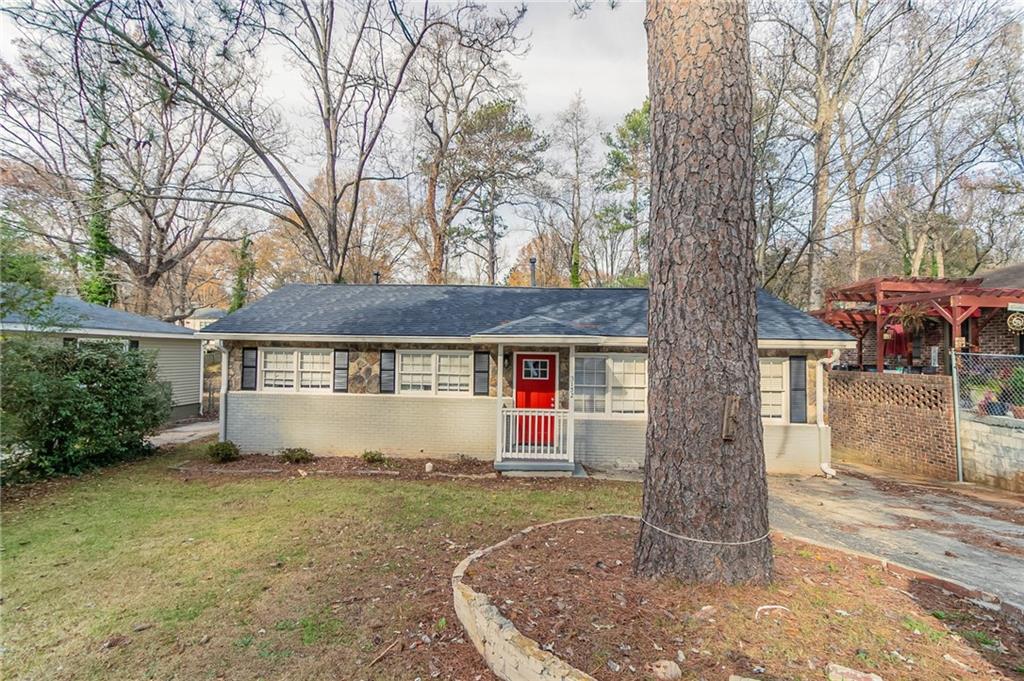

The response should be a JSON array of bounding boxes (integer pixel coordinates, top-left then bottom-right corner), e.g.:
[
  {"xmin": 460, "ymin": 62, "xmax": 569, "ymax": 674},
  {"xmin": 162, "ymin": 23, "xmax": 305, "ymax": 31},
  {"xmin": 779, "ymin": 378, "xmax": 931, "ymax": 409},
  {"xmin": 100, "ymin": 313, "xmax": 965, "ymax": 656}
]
[{"xmin": 812, "ymin": 276, "xmax": 1024, "ymax": 372}]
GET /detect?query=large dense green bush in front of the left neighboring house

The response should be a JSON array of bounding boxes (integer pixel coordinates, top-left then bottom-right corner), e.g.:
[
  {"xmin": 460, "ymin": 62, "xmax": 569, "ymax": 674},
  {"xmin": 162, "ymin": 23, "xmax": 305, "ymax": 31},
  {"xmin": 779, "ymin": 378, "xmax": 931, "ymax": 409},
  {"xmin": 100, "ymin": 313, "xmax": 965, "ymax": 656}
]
[{"xmin": 0, "ymin": 335, "xmax": 171, "ymax": 482}]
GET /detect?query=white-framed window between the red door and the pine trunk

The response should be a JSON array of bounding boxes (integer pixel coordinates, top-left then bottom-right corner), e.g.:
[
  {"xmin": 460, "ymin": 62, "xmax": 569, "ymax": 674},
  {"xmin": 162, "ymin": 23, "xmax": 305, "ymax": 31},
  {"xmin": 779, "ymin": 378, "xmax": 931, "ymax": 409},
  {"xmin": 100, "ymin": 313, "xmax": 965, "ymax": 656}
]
[{"xmin": 573, "ymin": 353, "xmax": 647, "ymax": 416}]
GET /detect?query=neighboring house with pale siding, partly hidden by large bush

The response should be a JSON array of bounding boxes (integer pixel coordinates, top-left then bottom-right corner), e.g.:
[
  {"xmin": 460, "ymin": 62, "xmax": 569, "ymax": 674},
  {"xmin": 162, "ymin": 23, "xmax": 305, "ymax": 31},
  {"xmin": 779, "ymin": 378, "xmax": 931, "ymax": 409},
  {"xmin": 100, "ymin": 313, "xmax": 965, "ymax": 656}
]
[{"xmin": 0, "ymin": 296, "xmax": 203, "ymax": 421}]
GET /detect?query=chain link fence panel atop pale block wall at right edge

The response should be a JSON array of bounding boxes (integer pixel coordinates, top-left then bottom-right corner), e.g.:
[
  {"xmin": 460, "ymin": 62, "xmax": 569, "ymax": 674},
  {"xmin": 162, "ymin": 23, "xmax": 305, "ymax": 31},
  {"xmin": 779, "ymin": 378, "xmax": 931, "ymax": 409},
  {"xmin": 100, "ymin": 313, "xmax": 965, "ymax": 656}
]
[{"xmin": 953, "ymin": 352, "xmax": 1024, "ymax": 420}]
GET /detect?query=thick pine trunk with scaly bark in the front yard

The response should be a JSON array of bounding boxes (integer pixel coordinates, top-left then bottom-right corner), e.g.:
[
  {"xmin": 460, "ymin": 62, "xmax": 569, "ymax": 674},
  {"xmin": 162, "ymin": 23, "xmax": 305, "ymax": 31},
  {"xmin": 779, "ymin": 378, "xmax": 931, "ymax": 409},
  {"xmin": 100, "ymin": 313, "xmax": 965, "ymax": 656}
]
[{"xmin": 635, "ymin": 0, "xmax": 772, "ymax": 583}]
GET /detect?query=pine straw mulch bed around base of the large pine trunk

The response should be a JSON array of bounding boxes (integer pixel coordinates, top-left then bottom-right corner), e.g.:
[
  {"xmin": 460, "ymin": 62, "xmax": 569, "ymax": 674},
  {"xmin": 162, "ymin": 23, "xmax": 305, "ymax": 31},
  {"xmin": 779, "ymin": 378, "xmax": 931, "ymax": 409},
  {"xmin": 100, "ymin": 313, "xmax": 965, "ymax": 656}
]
[{"xmin": 466, "ymin": 518, "xmax": 1024, "ymax": 681}]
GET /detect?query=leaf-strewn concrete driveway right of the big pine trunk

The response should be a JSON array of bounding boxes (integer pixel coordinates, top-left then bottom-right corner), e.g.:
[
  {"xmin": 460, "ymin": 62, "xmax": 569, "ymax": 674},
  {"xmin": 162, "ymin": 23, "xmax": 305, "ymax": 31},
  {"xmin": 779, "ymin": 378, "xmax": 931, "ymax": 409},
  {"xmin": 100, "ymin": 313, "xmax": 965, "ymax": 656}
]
[{"xmin": 768, "ymin": 467, "xmax": 1024, "ymax": 604}]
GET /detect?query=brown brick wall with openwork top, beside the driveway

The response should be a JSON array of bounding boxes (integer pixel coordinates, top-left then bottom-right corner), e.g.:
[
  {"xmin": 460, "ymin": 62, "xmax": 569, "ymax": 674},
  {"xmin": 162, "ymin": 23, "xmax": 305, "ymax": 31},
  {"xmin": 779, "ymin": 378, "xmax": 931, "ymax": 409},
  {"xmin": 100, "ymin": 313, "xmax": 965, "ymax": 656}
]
[{"xmin": 828, "ymin": 372, "xmax": 956, "ymax": 480}]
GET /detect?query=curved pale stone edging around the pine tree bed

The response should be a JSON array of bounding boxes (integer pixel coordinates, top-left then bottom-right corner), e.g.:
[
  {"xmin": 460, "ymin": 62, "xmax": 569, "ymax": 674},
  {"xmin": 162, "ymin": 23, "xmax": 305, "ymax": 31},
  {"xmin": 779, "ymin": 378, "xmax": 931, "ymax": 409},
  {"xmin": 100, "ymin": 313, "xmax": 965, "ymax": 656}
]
[{"xmin": 452, "ymin": 513, "xmax": 1024, "ymax": 681}]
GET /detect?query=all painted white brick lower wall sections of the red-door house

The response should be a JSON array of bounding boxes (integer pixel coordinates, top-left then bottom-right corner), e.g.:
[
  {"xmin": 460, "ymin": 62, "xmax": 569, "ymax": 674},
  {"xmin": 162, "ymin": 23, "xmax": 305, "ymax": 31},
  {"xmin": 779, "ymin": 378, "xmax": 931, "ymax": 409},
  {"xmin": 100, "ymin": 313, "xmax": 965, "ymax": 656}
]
[{"xmin": 227, "ymin": 391, "xmax": 830, "ymax": 474}]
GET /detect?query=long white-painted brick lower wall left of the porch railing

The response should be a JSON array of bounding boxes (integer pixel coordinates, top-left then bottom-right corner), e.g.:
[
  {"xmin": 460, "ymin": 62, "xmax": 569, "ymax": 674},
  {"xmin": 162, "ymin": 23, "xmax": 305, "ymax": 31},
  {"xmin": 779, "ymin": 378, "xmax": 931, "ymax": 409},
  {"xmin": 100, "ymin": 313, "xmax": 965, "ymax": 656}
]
[{"xmin": 226, "ymin": 392, "xmax": 498, "ymax": 460}]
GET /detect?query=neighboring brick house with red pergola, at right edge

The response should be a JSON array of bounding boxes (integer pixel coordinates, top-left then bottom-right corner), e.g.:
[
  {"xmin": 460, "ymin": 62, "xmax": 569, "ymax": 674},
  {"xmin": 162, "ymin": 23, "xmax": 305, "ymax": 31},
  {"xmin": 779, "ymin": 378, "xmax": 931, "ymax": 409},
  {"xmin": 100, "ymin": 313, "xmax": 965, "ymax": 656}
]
[{"xmin": 813, "ymin": 264, "xmax": 1024, "ymax": 374}]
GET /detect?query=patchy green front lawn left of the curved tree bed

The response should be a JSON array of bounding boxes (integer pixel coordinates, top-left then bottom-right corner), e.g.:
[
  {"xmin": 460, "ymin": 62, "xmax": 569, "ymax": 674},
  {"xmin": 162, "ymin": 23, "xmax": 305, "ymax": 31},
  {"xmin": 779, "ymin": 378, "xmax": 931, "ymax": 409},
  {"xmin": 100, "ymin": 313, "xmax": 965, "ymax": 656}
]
[{"xmin": 0, "ymin": 445, "xmax": 640, "ymax": 679}]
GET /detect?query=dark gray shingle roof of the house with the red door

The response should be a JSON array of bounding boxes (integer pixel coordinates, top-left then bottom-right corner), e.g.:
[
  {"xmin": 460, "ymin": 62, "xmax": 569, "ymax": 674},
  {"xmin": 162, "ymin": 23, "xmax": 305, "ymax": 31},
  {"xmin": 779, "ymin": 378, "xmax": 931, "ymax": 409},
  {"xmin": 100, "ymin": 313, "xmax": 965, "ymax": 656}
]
[{"xmin": 203, "ymin": 284, "xmax": 852, "ymax": 341}]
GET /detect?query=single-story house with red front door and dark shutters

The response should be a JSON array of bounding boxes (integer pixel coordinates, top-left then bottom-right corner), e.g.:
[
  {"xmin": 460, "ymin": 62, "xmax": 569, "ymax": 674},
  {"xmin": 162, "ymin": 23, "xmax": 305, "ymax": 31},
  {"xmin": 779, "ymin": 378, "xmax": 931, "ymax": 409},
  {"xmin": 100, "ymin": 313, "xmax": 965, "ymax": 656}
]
[{"xmin": 200, "ymin": 284, "xmax": 855, "ymax": 473}]
